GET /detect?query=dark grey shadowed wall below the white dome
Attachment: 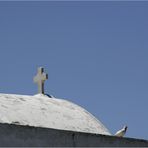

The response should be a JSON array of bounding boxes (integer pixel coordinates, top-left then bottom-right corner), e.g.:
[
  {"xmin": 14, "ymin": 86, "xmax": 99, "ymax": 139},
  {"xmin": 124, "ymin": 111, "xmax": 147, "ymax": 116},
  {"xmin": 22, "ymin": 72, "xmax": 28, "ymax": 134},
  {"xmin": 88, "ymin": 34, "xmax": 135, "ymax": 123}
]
[{"xmin": 0, "ymin": 123, "xmax": 148, "ymax": 147}]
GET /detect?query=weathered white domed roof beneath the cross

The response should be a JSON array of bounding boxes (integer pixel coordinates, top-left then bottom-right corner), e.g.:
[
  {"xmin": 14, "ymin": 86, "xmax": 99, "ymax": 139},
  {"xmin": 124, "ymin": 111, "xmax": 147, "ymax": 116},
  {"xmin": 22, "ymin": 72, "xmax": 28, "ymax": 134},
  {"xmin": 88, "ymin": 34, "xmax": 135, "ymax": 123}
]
[{"xmin": 0, "ymin": 94, "xmax": 110, "ymax": 135}]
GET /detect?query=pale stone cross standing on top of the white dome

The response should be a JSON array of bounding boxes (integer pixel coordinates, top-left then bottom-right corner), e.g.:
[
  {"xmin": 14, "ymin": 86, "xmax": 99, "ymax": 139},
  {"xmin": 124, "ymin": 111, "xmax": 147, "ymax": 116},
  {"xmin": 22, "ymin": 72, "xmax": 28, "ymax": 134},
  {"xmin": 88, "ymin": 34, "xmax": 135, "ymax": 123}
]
[{"xmin": 34, "ymin": 67, "xmax": 48, "ymax": 94}]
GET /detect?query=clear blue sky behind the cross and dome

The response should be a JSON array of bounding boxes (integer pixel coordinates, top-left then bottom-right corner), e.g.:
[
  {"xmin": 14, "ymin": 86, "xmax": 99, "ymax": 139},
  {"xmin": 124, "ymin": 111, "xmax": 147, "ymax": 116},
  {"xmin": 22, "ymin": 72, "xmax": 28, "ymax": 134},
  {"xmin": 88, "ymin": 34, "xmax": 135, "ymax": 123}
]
[{"xmin": 0, "ymin": 1, "xmax": 148, "ymax": 139}]
